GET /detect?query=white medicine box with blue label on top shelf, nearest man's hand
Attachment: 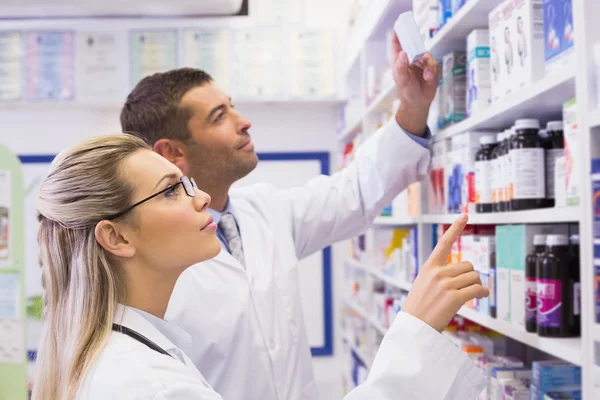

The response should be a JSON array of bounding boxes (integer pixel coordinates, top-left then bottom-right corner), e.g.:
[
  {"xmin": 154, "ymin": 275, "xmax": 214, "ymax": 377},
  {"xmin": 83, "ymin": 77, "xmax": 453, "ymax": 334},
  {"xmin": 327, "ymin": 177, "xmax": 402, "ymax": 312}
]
[{"xmin": 467, "ymin": 29, "xmax": 492, "ymax": 117}]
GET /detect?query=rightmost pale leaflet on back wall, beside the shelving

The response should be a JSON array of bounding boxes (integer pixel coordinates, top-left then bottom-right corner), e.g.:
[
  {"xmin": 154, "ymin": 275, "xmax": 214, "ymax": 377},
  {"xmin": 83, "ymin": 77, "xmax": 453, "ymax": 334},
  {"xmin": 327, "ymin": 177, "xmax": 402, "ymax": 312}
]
[{"xmin": 289, "ymin": 30, "xmax": 336, "ymax": 97}]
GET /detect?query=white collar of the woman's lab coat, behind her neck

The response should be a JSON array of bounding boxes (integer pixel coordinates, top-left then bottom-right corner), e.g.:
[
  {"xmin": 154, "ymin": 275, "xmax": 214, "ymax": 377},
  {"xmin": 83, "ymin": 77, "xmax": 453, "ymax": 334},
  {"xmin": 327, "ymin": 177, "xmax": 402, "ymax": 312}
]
[{"xmin": 114, "ymin": 304, "xmax": 192, "ymax": 353}]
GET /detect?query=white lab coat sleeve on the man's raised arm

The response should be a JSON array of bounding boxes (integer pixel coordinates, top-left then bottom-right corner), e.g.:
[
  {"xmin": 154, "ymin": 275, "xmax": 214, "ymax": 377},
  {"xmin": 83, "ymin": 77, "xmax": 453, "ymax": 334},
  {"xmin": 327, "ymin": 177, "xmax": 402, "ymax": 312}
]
[{"xmin": 281, "ymin": 118, "xmax": 430, "ymax": 258}]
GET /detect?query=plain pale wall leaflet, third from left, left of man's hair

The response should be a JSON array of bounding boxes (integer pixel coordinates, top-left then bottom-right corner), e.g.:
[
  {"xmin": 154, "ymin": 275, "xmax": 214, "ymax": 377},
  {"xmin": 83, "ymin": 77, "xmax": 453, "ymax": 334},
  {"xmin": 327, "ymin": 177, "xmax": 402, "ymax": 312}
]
[{"xmin": 77, "ymin": 32, "xmax": 127, "ymax": 101}]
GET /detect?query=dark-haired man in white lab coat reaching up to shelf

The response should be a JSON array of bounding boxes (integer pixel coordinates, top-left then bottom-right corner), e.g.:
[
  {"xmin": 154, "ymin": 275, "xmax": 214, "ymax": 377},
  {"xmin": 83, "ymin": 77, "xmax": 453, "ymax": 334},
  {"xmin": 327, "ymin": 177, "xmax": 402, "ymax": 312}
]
[{"xmin": 121, "ymin": 40, "xmax": 468, "ymax": 400}]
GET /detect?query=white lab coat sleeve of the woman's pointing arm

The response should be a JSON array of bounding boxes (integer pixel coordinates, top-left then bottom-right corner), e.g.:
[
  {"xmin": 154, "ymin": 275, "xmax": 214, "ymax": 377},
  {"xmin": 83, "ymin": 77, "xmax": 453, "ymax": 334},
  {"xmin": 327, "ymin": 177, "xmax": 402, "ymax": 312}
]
[{"xmin": 344, "ymin": 312, "xmax": 485, "ymax": 400}]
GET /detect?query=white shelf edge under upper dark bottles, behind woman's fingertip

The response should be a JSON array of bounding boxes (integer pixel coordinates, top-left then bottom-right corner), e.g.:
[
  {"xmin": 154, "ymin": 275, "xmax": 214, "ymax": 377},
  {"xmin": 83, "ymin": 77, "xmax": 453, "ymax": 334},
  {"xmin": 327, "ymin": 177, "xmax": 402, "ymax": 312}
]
[{"xmin": 421, "ymin": 206, "xmax": 581, "ymax": 225}]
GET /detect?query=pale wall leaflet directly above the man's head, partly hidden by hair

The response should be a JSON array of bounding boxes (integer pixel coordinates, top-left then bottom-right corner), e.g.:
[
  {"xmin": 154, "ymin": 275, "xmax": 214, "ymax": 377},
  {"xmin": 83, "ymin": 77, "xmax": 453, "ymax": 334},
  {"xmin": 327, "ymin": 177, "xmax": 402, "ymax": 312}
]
[{"xmin": 183, "ymin": 29, "xmax": 232, "ymax": 92}]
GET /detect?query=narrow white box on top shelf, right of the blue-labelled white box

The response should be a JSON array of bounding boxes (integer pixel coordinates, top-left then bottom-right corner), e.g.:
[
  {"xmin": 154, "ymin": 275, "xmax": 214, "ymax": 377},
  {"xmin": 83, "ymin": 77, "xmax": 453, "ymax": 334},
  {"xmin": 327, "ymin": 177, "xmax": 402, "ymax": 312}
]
[{"xmin": 488, "ymin": 3, "xmax": 506, "ymax": 103}]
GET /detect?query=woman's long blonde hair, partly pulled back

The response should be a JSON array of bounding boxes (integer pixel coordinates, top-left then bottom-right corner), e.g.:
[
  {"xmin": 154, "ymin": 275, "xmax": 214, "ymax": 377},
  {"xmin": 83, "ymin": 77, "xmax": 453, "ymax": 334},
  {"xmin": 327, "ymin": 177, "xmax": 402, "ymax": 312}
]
[{"xmin": 33, "ymin": 134, "xmax": 149, "ymax": 400}]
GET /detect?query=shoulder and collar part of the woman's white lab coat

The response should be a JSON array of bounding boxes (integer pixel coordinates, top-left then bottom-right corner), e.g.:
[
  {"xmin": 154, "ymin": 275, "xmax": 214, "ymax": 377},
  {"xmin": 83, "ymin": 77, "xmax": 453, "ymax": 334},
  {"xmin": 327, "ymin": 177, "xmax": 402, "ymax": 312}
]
[{"xmin": 77, "ymin": 305, "xmax": 221, "ymax": 400}]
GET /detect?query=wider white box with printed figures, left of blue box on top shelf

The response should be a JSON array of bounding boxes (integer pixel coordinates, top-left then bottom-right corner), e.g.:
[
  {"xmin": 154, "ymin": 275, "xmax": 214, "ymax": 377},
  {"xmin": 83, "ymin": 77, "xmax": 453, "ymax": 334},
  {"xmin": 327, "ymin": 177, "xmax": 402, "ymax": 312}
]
[{"xmin": 502, "ymin": 0, "xmax": 545, "ymax": 94}]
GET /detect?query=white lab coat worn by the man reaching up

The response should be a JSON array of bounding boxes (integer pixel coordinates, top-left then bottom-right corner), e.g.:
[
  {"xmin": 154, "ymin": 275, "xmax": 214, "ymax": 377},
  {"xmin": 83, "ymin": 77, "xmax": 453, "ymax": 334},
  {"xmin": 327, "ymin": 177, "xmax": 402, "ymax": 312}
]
[{"xmin": 165, "ymin": 118, "xmax": 468, "ymax": 400}]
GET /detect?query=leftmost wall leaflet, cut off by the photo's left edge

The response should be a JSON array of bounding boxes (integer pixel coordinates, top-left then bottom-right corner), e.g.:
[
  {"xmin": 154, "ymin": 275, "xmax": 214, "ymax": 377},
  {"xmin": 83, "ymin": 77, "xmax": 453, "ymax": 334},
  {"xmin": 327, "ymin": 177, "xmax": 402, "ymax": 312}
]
[{"xmin": 0, "ymin": 32, "xmax": 25, "ymax": 101}]
